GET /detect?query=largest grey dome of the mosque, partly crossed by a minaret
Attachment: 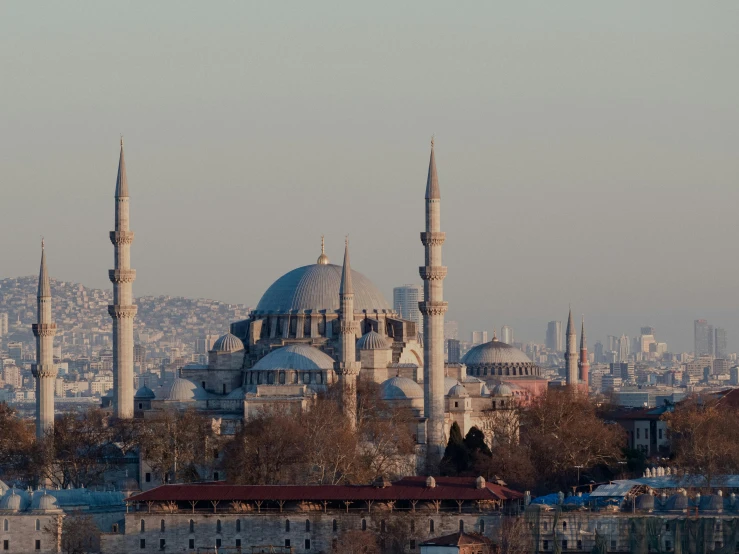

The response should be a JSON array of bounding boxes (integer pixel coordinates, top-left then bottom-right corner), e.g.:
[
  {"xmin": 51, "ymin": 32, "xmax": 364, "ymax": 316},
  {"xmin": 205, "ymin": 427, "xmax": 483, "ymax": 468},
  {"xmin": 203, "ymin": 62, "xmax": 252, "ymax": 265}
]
[{"xmin": 256, "ymin": 264, "xmax": 392, "ymax": 314}]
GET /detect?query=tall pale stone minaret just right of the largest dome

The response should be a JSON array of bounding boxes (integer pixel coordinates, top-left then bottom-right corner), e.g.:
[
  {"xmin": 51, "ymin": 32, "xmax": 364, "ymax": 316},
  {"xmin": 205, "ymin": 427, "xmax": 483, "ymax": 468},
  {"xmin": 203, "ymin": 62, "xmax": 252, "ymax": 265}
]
[{"xmin": 418, "ymin": 139, "xmax": 447, "ymax": 462}]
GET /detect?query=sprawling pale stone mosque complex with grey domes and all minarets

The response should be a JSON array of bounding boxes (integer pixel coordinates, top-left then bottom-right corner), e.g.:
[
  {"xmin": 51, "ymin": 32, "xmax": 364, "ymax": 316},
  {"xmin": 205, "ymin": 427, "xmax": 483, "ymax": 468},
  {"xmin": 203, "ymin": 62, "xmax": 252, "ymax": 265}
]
[{"xmin": 34, "ymin": 137, "xmax": 587, "ymax": 461}]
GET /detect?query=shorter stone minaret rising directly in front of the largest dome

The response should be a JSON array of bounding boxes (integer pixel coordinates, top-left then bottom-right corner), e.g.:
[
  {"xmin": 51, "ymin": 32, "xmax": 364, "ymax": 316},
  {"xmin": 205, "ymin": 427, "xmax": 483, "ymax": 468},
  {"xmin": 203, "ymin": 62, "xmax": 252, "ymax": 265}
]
[{"xmin": 336, "ymin": 239, "xmax": 360, "ymax": 422}]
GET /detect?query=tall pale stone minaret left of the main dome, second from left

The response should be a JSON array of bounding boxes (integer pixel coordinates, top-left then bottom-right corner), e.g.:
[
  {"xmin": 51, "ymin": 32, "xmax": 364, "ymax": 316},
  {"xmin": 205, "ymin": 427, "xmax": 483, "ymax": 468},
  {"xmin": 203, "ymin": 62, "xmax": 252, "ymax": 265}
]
[{"xmin": 108, "ymin": 138, "xmax": 136, "ymax": 418}]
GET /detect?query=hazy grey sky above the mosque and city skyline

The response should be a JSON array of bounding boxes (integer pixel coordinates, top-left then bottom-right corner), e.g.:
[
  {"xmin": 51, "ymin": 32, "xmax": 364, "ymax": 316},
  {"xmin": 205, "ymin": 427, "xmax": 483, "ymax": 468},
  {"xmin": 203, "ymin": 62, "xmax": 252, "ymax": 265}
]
[{"xmin": 0, "ymin": 0, "xmax": 739, "ymax": 351}]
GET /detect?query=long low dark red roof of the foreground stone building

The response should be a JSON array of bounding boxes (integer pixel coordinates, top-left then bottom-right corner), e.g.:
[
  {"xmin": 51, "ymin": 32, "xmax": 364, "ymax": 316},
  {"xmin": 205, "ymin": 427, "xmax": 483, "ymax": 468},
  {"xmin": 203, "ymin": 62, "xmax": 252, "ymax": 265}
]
[{"xmin": 128, "ymin": 477, "xmax": 523, "ymax": 502}]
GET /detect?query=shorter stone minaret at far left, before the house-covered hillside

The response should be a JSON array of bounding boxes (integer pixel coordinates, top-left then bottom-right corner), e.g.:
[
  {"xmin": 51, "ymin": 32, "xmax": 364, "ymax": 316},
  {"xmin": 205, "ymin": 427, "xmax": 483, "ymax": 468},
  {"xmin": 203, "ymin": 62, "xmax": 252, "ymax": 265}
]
[{"xmin": 33, "ymin": 240, "xmax": 56, "ymax": 439}]
